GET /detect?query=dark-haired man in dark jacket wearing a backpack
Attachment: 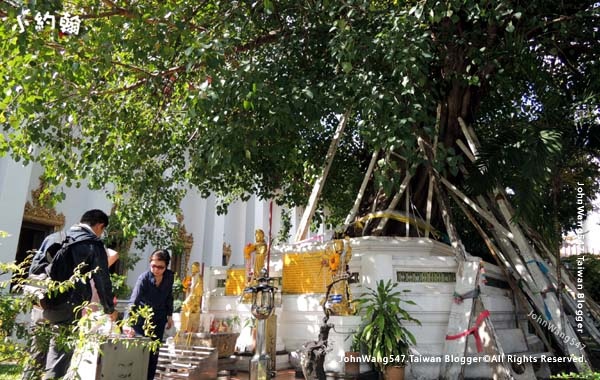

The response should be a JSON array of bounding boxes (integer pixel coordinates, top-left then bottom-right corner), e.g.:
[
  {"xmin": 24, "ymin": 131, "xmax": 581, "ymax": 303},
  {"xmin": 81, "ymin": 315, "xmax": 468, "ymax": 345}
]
[{"xmin": 24, "ymin": 209, "xmax": 117, "ymax": 379}]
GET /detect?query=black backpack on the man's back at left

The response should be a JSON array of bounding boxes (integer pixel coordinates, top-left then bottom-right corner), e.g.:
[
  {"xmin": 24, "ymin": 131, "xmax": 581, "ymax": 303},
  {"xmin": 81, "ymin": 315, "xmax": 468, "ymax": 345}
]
[{"xmin": 26, "ymin": 235, "xmax": 93, "ymax": 309}]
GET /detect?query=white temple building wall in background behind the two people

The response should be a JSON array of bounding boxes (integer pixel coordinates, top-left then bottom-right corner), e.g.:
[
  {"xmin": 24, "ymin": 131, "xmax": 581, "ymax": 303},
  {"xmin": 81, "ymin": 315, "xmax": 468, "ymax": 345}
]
[{"xmin": 0, "ymin": 153, "xmax": 308, "ymax": 292}]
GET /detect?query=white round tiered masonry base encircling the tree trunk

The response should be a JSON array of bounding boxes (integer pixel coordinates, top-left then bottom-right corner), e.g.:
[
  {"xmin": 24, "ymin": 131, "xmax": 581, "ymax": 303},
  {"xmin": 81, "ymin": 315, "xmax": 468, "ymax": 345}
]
[{"xmin": 205, "ymin": 237, "xmax": 530, "ymax": 379}]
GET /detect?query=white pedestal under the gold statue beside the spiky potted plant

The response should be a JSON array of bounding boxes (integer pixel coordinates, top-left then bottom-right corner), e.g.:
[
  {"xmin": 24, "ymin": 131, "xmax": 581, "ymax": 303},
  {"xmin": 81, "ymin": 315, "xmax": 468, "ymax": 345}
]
[{"xmin": 324, "ymin": 315, "xmax": 360, "ymax": 373}]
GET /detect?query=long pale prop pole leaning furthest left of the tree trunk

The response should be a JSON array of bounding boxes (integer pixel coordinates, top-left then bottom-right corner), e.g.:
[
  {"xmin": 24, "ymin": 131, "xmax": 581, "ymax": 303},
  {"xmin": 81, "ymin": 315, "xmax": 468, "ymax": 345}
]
[{"xmin": 295, "ymin": 109, "xmax": 351, "ymax": 242}]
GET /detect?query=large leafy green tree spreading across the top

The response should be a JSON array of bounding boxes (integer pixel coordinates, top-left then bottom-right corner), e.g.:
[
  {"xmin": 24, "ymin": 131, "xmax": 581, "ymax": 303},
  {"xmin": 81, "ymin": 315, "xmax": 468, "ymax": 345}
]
[{"xmin": 0, "ymin": 0, "xmax": 600, "ymax": 249}]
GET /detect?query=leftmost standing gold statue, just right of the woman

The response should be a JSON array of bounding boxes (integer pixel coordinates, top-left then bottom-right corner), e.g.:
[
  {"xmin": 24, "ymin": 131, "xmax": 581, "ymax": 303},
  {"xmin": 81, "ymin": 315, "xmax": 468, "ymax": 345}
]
[{"xmin": 181, "ymin": 261, "xmax": 204, "ymax": 332}]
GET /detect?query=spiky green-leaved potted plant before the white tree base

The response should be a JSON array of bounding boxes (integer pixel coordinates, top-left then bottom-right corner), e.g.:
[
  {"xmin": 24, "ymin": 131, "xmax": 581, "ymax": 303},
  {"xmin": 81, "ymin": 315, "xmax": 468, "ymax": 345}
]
[{"xmin": 356, "ymin": 280, "xmax": 421, "ymax": 380}]
